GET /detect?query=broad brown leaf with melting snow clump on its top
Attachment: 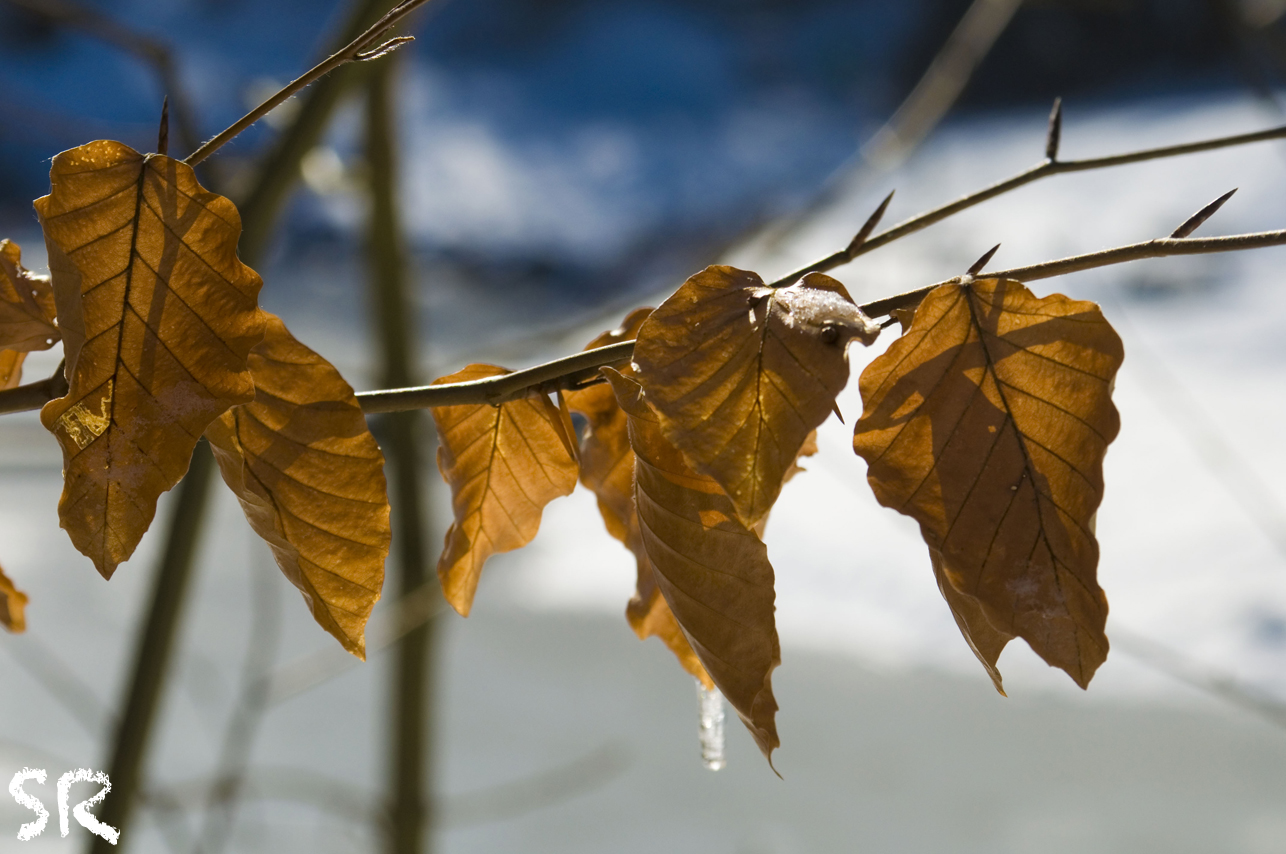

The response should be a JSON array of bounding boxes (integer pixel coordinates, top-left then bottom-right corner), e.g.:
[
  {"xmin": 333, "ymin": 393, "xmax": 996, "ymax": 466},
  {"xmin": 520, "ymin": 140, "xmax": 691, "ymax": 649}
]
[{"xmin": 634, "ymin": 266, "xmax": 880, "ymax": 527}]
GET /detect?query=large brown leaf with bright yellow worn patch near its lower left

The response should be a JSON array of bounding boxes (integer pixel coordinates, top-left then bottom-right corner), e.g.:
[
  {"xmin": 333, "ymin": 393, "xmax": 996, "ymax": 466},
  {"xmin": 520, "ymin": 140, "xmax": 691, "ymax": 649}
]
[{"xmin": 35, "ymin": 140, "xmax": 264, "ymax": 577}]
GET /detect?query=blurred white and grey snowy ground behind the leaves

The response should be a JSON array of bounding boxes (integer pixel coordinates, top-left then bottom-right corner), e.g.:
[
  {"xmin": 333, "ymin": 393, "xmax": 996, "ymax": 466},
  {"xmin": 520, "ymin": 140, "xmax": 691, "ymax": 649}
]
[{"xmin": 0, "ymin": 90, "xmax": 1286, "ymax": 854}]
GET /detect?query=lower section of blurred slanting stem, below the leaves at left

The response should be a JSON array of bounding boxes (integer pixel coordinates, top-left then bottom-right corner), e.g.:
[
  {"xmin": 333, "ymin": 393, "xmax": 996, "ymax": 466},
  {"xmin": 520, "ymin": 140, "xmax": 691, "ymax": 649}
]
[{"xmin": 90, "ymin": 441, "xmax": 215, "ymax": 854}]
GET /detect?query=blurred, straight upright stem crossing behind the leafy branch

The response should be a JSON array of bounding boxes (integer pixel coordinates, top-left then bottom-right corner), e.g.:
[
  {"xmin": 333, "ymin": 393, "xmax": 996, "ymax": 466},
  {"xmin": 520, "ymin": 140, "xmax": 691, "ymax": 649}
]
[{"xmin": 367, "ymin": 56, "xmax": 435, "ymax": 854}]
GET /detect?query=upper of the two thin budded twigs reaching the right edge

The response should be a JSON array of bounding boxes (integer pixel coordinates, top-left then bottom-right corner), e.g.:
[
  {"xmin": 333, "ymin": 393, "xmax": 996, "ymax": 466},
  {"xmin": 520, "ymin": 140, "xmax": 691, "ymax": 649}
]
[{"xmin": 772, "ymin": 120, "xmax": 1286, "ymax": 287}]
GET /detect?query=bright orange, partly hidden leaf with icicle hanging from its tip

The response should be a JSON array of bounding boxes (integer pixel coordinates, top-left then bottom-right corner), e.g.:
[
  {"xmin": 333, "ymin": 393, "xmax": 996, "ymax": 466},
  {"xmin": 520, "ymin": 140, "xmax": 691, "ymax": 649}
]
[{"xmin": 563, "ymin": 309, "xmax": 714, "ymax": 688}]
